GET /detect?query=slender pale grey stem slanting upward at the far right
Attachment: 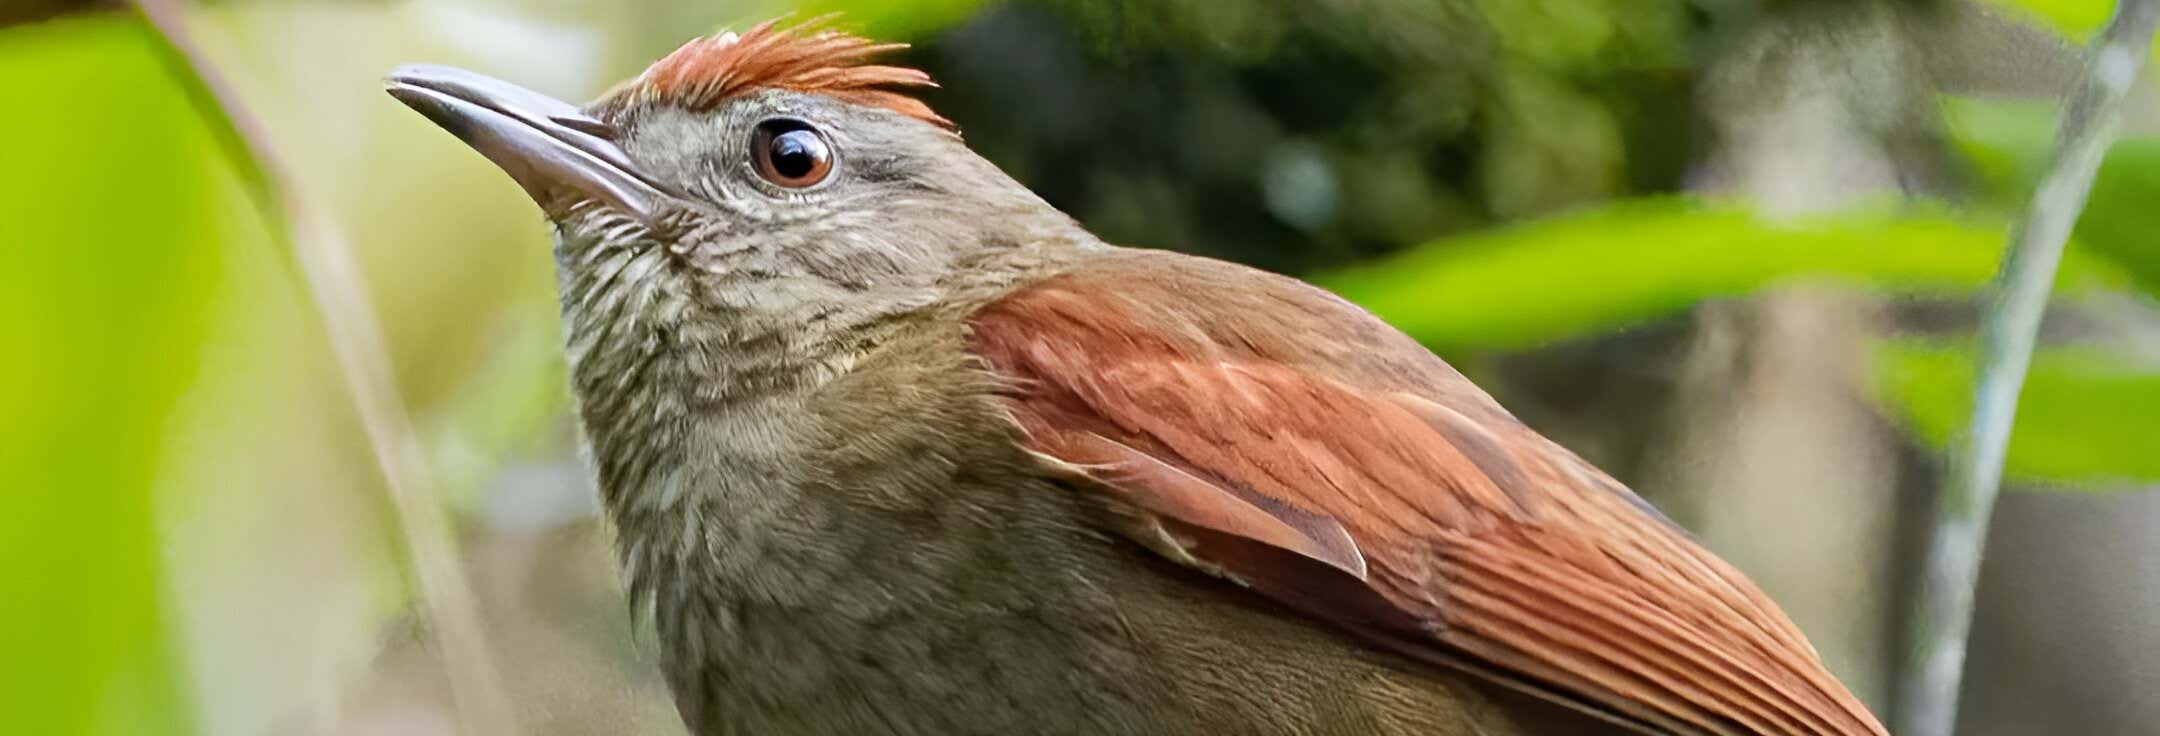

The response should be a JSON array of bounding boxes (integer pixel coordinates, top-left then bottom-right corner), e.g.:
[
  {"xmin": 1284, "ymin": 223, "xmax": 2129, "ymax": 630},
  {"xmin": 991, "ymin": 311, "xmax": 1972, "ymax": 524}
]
[{"xmin": 1896, "ymin": 0, "xmax": 2160, "ymax": 736}]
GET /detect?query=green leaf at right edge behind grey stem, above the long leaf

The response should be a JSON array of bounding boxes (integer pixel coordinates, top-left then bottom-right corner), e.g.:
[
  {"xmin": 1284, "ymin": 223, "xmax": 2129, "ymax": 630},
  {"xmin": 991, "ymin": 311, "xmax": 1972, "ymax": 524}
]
[{"xmin": 1942, "ymin": 99, "xmax": 2160, "ymax": 294}]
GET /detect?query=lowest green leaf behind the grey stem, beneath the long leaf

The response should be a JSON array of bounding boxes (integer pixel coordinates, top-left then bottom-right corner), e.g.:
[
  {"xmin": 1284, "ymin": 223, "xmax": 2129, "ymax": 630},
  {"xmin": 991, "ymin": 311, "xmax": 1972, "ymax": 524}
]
[{"xmin": 1875, "ymin": 339, "xmax": 2160, "ymax": 488}]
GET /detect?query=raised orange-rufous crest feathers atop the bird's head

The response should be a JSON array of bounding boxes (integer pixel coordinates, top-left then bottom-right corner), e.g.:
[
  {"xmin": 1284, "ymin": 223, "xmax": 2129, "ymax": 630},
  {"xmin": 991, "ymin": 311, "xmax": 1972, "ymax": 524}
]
[{"xmin": 603, "ymin": 19, "xmax": 955, "ymax": 130}]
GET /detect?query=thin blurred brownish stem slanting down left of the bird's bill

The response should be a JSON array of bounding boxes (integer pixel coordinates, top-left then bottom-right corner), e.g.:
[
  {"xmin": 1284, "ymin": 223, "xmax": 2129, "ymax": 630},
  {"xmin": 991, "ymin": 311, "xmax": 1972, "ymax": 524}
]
[{"xmin": 132, "ymin": 0, "xmax": 514, "ymax": 734}]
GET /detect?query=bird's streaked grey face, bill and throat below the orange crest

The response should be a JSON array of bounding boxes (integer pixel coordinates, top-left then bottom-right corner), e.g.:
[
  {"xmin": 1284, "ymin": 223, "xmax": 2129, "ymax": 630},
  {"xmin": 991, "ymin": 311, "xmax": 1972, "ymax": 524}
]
[{"xmin": 389, "ymin": 67, "xmax": 1086, "ymax": 391}]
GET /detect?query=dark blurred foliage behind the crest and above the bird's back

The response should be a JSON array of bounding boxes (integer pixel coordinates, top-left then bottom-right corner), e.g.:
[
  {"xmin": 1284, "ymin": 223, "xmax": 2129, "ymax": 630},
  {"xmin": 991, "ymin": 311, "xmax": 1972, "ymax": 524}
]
[{"xmin": 907, "ymin": 0, "xmax": 1698, "ymax": 274}]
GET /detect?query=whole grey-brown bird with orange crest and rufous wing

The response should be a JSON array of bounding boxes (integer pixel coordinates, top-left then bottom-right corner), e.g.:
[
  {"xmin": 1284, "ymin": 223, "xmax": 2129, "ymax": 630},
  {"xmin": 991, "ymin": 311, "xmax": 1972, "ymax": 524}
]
[{"xmin": 387, "ymin": 22, "xmax": 1884, "ymax": 736}]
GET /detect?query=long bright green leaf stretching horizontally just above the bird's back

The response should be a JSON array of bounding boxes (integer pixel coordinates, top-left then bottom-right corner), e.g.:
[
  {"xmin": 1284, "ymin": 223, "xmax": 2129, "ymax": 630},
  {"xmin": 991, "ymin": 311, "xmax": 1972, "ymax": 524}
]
[{"xmin": 1320, "ymin": 199, "xmax": 2121, "ymax": 350}]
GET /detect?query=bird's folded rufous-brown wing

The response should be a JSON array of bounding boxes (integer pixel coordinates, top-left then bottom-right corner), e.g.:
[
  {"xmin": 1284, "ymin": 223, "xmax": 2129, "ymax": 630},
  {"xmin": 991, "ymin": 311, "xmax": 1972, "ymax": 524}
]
[{"xmin": 970, "ymin": 250, "xmax": 1884, "ymax": 736}]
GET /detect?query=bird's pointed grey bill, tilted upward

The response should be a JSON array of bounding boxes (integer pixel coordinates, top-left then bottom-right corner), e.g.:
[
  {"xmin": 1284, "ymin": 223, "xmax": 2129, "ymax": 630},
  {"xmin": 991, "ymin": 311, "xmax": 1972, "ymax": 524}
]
[{"xmin": 384, "ymin": 65, "xmax": 667, "ymax": 220}]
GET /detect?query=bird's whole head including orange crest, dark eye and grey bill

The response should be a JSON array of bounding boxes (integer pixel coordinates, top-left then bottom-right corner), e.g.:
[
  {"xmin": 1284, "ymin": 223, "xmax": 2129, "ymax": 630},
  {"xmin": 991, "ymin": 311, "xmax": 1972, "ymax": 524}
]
[{"xmin": 387, "ymin": 22, "xmax": 1071, "ymax": 349}]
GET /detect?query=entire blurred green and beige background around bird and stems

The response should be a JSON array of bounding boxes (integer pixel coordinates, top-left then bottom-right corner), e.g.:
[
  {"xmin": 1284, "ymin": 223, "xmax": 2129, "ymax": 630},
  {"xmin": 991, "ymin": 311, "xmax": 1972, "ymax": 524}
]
[{"xmin": 0, "ymin": 0, "xmax": 2160, "ymax": 736}]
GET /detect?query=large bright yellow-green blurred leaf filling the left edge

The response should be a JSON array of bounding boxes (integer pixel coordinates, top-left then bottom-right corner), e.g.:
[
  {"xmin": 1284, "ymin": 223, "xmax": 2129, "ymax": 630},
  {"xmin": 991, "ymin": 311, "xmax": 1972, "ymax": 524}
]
[{"xmin": 0, "ymin": 15, "xmax": 221, "ymax": 734}]
